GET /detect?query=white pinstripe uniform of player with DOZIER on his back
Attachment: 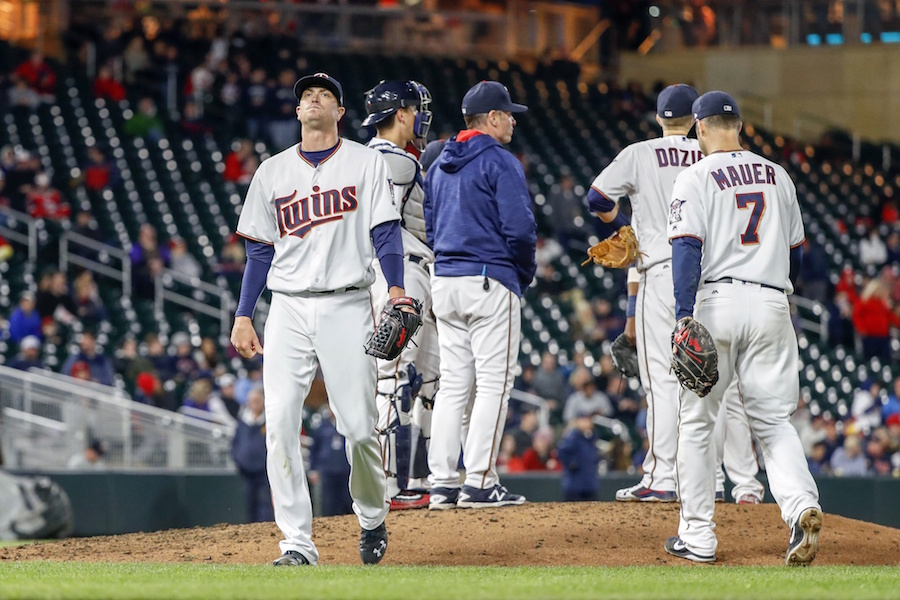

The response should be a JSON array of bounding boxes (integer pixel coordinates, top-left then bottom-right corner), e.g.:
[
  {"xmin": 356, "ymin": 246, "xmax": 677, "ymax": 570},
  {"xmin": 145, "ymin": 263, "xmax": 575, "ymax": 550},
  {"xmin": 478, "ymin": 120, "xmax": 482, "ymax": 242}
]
[{"xmin": 591, "ymin": 135, "xmax": 763, "ymax": 500}]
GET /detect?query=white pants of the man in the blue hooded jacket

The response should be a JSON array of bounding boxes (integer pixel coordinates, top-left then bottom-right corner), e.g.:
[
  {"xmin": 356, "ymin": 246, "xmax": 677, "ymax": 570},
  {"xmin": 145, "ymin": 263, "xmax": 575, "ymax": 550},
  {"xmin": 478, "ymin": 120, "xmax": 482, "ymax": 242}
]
[{"xmin": 428, "ymin": 276, "xmax": 522, "ymax": 489}]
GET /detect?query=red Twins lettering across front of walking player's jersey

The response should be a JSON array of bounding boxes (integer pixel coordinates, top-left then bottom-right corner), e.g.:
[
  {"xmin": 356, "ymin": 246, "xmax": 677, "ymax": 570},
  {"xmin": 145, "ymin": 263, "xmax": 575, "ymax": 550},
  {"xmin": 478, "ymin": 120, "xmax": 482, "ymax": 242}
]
[{"xmin": 275, "ymin": 185, "xmax": 358, "ymax": 238}]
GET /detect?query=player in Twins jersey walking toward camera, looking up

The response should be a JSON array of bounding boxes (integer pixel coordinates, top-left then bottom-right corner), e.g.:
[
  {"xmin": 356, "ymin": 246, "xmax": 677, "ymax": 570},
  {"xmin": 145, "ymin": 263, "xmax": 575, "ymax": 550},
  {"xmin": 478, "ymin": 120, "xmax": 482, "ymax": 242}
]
[{"xmin": 231, "ymin": 73, "xmax": 416, "ymax": 566}]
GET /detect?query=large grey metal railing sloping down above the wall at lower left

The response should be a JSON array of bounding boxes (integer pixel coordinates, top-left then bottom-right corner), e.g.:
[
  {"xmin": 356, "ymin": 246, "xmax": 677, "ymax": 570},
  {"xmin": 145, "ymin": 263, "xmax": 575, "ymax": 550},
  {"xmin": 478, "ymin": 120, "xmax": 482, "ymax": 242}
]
[{"xmin": 0, "ymin": 366, "xmax": 234, "ymax": 471}]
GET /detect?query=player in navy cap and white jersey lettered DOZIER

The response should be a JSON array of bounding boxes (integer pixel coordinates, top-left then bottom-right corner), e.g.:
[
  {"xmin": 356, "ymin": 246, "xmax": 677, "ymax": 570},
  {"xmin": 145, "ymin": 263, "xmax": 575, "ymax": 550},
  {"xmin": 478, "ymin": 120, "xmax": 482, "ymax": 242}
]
[{"xmin": 588, "ymin": 84, "xmax": 763, "ymax": 502}]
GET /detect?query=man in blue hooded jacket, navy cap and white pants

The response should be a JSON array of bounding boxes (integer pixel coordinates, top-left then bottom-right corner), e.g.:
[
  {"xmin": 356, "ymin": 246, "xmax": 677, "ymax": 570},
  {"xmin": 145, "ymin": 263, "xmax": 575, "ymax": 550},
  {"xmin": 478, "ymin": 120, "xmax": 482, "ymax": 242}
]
[{"xmin": 425, "ymin": 81, "xmax": 536, "ymax": 510}]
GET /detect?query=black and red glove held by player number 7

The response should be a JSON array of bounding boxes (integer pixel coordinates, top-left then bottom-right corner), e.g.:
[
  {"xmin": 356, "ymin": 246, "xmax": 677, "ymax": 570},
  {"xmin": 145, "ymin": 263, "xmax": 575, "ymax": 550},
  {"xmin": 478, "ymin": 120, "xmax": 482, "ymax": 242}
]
[{"xmin": 672, "ymin": 317, "xmax": 719, "ymax": 398}]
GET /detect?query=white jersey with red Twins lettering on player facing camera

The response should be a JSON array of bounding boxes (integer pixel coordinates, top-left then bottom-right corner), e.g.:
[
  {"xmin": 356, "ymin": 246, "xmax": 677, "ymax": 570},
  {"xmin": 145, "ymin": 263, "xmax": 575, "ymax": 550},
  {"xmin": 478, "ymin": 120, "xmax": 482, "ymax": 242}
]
[{"xmin": 237, "ymin": 139, "xmax": 400, "ymax": 294}]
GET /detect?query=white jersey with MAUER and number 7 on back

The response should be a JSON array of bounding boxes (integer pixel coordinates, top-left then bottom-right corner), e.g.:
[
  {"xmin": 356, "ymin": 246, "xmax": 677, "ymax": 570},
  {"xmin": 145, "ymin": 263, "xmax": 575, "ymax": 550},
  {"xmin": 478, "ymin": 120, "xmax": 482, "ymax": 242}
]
[{"xmin": 668, "ymin": 151, "xmax": 805, "ymax": 294}]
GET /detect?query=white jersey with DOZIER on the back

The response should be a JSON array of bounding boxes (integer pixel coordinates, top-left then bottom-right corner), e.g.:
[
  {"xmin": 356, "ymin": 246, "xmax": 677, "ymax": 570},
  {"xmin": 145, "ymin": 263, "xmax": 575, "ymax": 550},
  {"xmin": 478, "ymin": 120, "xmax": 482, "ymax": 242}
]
[{"xmin": 591, "ymin": 135, "xmax": 703, "ymax": 271}]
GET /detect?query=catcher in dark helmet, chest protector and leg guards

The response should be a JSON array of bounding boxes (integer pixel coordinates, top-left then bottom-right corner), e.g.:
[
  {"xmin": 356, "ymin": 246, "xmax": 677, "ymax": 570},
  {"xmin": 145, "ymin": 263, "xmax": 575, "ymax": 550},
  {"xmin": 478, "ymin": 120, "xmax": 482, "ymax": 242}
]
[{"xmin": 363, "ymin": 81, "xmax": 440, "ymax": 510}]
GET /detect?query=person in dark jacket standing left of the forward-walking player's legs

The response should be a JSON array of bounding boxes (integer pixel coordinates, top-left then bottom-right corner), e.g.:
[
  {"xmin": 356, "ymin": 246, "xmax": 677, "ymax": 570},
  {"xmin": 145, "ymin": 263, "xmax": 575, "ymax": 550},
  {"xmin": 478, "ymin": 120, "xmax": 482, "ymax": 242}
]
[{"xmin": 231, "ymin": 387, "xmax": 270, "ymax": 523}]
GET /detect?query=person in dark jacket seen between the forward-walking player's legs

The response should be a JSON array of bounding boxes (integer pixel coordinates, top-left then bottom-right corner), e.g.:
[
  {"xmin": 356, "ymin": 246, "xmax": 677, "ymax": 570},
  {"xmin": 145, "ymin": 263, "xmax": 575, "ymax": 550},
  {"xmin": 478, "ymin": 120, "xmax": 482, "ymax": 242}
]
[{"xmin": 309, "ymin": 407, "xmax": 353, "ymax": 517}]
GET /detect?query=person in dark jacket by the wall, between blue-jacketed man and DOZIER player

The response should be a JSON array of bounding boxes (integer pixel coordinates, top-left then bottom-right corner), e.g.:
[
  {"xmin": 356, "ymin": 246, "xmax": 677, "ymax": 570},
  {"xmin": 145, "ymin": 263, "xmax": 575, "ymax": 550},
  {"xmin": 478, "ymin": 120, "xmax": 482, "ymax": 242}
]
[{"xmin": 557, "ymin": 413, "xmax": 600, "ymax": 502}]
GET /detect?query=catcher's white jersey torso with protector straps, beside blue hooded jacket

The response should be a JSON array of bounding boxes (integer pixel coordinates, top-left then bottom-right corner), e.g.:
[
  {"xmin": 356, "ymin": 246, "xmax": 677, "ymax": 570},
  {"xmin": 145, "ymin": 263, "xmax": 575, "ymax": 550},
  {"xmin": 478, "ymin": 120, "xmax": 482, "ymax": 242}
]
[{"xmin": 368, "ymin": 137, "xmax": 434, "ymax": 263}]
